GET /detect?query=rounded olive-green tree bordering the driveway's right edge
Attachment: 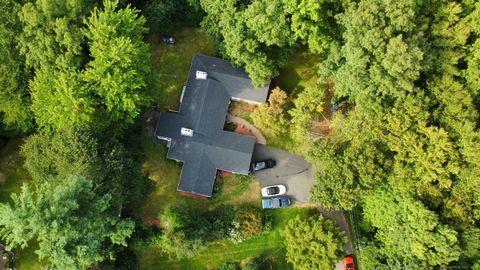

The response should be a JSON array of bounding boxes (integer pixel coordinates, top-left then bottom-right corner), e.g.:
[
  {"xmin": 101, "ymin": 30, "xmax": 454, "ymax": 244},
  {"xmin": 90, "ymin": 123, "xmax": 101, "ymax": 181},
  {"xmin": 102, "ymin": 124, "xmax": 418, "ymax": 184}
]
[{"xmin": 307, "ymin": 106, "xmax": 392, "ymax": 209}]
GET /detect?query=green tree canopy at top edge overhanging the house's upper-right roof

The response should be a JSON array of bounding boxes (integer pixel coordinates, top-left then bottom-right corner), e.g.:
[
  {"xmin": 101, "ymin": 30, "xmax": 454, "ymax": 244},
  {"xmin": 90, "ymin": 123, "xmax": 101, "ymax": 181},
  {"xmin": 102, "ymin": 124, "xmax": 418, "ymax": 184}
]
[{"xmin": 200, "ymin": 0, "xmax": 341, "ymax": 86}]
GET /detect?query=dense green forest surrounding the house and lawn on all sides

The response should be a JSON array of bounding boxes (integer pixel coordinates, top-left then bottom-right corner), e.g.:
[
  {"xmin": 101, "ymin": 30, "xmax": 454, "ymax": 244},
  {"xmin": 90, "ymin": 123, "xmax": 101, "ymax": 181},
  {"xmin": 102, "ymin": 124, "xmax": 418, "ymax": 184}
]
[{"xmin": 0, "ymin": 0, "xmax": 480, "ymax": 269}]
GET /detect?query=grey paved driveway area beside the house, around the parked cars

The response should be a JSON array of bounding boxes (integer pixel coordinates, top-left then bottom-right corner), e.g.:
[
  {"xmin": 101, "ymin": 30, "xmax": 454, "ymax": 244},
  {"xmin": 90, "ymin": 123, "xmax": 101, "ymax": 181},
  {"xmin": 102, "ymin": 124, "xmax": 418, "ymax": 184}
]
[{"xmin": 252, "ymin": 144, "xmax": 313, "ymax": 205}]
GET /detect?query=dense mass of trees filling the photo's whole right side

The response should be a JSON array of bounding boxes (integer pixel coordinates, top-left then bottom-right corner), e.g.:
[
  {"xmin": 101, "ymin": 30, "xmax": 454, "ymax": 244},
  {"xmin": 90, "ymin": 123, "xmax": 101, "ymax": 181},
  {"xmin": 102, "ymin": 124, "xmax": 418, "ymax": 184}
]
[{"xmin": 310, "ymin": 0, "xmax": 480, "ymax": 269}]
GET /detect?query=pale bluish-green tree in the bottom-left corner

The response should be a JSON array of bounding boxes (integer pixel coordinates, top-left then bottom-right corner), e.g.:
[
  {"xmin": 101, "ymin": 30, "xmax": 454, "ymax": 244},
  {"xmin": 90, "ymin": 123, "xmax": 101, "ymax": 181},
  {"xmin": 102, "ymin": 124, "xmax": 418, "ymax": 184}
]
[{"xmin": 0, "ymin": 177, "xmax": 134, "ymax": 269}]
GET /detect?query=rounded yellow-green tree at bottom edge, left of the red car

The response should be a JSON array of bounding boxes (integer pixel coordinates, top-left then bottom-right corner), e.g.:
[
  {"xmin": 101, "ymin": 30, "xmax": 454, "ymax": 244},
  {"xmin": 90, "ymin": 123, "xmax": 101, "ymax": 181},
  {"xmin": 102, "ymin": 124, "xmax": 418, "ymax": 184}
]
[{"xmin": 283, "ymin": 216, "xmax": 346, "ymax": 270}]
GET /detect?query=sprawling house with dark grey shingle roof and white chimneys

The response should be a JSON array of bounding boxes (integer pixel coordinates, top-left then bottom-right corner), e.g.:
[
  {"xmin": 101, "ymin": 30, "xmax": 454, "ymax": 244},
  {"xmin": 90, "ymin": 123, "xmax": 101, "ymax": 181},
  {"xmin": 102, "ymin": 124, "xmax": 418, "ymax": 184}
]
[{"xmin": 155, "ymin": 54, "xmax": 268, "ymax": 197}]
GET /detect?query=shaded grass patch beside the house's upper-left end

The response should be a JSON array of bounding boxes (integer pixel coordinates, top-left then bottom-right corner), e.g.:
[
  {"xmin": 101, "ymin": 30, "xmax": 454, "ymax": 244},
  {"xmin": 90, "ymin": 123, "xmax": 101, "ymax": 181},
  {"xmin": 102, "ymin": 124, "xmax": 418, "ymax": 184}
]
[{"xmin": 147, "ymin": 27, "xmax": 215, "ymax": 110}]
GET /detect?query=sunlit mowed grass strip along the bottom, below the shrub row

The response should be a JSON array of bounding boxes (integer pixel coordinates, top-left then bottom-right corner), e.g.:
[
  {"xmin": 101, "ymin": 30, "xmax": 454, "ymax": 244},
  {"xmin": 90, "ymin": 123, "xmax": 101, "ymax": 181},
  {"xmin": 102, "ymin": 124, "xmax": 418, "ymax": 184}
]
[{"xmin": 137, "ymin": 208, "xmax": 316, "ymax": 270}]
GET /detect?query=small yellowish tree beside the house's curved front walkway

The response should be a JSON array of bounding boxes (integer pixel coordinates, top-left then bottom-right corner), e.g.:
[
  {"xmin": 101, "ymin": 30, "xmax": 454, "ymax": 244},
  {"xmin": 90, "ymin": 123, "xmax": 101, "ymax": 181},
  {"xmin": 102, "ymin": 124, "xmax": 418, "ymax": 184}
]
[{"xmin": 251, "ymin": 87, "xmax": 288, "ymax": 137}]
